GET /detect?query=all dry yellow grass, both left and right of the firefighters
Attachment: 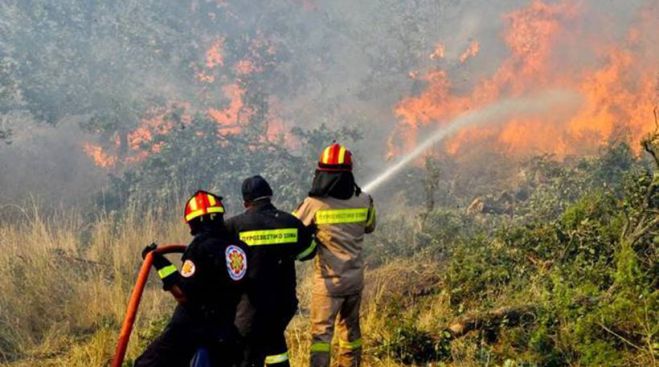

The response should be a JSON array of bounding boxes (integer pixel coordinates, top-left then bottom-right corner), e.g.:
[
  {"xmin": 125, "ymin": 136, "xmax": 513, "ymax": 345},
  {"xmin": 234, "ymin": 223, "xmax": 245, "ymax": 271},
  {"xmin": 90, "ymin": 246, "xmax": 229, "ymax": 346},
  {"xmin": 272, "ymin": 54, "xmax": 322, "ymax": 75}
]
[{"xmin": 0, "ymin": 209, "xmax": 465, "ymax": 367}]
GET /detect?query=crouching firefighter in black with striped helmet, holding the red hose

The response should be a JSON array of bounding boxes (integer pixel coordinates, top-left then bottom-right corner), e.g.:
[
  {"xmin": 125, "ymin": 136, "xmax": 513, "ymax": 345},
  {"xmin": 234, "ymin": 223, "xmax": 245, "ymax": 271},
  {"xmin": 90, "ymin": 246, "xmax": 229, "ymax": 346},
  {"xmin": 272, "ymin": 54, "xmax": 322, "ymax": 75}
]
[{"xmin": 135, "ymin": 191, "xmax": 248, "ymax": 367}]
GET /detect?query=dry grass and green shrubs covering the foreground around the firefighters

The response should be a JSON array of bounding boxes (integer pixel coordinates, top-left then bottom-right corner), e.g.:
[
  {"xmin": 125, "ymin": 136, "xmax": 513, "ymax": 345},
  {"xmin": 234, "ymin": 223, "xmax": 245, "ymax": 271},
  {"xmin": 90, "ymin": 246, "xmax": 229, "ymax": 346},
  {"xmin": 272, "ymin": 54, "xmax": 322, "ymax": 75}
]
[{"xmin": 0, "ymin": 139, "xmax": 659, "ymax": 367}]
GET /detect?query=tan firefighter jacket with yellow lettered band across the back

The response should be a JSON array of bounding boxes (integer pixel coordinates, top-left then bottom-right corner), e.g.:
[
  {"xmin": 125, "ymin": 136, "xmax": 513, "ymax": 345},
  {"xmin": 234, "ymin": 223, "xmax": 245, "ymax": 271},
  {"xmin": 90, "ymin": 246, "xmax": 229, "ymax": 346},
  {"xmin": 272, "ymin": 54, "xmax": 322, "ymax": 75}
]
[{"xmin": 294, "ymin": 192, "xmax": 376, "ymax": 296}]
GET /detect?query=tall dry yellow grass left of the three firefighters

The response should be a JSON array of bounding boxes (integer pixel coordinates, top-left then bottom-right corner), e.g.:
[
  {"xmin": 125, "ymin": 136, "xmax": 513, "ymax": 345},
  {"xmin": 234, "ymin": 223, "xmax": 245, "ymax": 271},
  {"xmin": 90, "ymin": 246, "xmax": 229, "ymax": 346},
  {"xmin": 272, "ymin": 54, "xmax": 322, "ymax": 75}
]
[{"xmin": 0, "ymin": 208, "xmax": 188, "ymax": 366}]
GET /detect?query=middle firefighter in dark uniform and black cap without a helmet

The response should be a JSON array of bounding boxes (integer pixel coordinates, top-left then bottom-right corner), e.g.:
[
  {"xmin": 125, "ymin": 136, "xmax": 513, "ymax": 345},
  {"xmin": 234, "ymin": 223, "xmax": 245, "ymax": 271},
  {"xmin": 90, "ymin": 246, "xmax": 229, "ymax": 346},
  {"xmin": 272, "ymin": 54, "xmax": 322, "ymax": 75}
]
[{"xmin": 226, "ymin": 176, "xmax": 316, "ymax": 367}]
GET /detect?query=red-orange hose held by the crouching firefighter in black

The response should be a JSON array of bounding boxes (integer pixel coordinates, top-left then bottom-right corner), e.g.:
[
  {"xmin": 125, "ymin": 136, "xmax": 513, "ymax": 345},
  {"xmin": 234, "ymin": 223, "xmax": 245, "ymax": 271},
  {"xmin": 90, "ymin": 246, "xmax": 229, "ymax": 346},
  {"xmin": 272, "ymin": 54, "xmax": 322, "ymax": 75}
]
[{"xmin": 111, "ymin": 245, "xmax": 186, "ymax": 367}]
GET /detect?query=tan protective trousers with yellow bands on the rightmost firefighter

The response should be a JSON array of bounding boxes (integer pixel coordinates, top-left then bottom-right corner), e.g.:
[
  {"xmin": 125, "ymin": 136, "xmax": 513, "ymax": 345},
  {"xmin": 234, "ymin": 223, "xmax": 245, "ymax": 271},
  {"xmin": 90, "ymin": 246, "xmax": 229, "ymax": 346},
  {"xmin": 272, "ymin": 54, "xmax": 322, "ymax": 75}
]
[{"xmin": 311, "ymin": 293, "xmax": 362, "ymax": 367}]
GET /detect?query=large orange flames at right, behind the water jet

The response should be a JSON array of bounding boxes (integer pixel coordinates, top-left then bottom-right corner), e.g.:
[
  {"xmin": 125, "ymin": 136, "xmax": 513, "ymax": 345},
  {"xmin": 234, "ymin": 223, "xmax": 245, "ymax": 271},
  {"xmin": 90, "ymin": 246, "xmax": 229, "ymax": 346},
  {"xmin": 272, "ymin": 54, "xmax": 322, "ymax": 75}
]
[{"xmin": 388, "ymin": 0, "xmax": 659, "ymax": 157}]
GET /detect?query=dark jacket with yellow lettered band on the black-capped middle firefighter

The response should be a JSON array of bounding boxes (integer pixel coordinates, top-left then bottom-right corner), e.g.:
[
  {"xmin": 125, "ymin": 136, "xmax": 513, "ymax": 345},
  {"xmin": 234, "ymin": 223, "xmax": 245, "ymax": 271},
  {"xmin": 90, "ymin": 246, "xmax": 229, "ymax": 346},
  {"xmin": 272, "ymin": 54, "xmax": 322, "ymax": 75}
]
[{"xmin": 226, "ymin": 202, "xmax": 315, "ymax": 322}]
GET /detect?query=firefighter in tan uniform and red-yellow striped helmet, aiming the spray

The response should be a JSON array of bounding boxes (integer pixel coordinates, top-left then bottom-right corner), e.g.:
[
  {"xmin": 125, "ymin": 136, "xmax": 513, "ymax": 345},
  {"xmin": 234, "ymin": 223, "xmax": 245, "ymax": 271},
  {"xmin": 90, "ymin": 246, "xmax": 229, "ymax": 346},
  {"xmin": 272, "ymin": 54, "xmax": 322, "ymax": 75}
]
[{"xmin": 294, "ymin": 144, "xmax": 375, "ymax": 367}]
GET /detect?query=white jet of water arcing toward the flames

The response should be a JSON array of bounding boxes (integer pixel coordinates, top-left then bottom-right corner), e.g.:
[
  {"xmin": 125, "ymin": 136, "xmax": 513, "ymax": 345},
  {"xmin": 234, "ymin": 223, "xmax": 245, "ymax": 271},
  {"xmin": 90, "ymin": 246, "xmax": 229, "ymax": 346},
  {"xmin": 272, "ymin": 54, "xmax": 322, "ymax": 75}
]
[{"xmin": 364, "ymin": 90, "xmax": 581, "ymax": 192}]
